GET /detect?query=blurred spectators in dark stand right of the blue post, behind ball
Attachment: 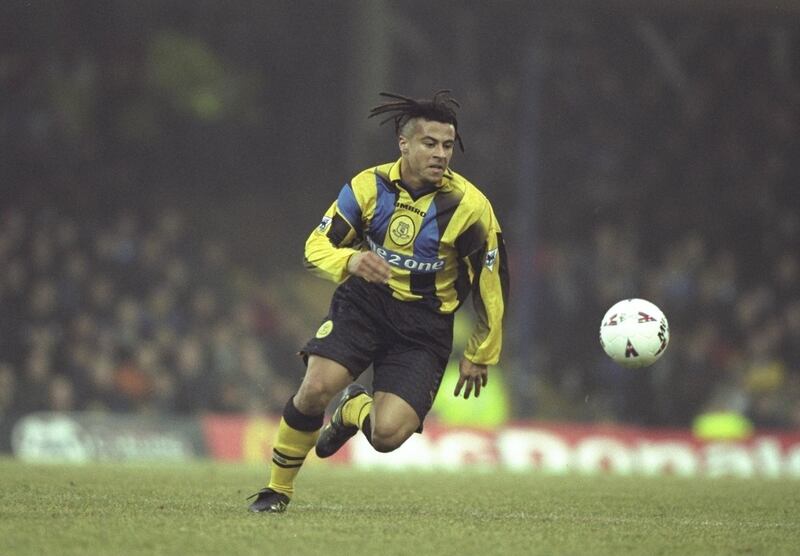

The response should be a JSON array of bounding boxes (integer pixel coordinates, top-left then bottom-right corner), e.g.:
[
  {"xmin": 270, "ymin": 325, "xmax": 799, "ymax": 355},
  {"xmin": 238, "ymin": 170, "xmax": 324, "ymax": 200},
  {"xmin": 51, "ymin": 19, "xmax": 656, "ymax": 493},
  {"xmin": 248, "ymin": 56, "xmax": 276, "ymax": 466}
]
[{"xmin": 532, "ymin": 16, "xmax": 800, "ymax": 428}]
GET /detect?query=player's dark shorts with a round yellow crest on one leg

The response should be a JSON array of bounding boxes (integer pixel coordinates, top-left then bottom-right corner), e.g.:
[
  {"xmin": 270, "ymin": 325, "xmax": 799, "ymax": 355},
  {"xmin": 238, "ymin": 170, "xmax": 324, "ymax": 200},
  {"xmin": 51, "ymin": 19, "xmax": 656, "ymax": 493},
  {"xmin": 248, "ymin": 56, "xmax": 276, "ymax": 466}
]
[{"xmin": 300, "ymin": 276, "xmax": 453, "ymax": 423}]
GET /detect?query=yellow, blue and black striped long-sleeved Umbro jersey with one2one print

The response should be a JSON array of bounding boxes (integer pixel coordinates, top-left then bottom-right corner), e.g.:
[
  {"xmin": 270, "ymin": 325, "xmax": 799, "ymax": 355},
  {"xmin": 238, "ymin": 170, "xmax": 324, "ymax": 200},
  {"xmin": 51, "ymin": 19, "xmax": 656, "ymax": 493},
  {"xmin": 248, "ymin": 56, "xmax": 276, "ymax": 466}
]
[{"xmin": 305, "ymin": 160, "xmax": 508, "ymax": 365}]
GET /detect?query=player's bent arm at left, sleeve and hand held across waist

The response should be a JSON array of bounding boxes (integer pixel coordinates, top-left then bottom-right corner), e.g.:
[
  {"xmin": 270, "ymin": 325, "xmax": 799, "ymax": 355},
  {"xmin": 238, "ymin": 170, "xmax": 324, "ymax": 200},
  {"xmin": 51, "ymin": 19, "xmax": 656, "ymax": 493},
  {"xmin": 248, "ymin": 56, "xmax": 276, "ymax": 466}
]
[{"xmin": 304, "ymin": 184, "xmax": 391, "ymax": 283}]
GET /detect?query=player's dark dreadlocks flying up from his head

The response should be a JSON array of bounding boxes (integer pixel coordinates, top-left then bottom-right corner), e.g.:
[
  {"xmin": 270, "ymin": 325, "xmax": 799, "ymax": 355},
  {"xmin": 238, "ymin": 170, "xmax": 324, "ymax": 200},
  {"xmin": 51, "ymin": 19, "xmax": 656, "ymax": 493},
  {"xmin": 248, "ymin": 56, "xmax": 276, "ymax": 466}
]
[{"xmin": 368, "ymin": 89, "xmax": 464, "ymax": 152}]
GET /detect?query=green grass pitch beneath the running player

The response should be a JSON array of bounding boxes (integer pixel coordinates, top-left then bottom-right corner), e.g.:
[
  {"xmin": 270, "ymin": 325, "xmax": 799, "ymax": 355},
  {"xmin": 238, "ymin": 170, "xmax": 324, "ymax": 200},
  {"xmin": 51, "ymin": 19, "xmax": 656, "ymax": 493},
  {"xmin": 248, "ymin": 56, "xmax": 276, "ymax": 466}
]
[{"xmin": 0, "ymin": 459, "xmax": 800, "ymax": 556}]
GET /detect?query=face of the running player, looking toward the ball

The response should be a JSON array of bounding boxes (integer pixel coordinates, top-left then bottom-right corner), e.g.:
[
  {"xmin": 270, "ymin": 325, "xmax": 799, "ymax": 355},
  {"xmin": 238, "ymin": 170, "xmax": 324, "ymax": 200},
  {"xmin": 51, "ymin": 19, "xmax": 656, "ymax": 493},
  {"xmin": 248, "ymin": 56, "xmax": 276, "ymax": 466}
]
[{"xmin": 399, "ymin": 118, "xmax": 456, "ymax": 187}]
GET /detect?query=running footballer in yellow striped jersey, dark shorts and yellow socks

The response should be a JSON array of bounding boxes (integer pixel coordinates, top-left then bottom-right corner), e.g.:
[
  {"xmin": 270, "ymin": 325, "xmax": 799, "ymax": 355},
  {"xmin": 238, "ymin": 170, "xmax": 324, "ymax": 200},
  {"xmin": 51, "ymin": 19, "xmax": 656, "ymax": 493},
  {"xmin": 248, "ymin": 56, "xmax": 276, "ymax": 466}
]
[{"xmin": 250, "ymin": 90, "xmax": 508, "ymax": 512}]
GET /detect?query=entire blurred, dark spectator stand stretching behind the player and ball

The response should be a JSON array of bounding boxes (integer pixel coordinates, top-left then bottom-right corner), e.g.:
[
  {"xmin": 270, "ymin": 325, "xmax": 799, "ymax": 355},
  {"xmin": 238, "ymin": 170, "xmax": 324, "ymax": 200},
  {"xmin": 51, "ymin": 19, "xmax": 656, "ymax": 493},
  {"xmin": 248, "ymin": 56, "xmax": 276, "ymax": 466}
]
[{"xmin": 0, "ymin": 4, "xmax": 800, "ymax": 428}]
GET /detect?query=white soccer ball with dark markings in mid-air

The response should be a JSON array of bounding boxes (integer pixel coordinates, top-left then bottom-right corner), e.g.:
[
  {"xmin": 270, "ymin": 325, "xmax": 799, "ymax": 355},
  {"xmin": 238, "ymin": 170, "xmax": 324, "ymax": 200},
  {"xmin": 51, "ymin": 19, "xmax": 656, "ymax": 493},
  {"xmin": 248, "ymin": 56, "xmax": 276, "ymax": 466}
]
[{"xmin": 600, "ymin": 299, "xmax": 669, "ymax": 369}]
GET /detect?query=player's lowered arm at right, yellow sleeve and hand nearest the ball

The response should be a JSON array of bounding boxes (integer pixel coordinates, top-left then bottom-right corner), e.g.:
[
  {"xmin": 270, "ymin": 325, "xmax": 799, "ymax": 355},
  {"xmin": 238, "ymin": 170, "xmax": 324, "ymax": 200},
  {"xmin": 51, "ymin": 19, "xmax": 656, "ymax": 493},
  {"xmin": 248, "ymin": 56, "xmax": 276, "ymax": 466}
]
[{"xmin": 455, "ymin": 202, "xmax": 509, "ymax": 397}]
